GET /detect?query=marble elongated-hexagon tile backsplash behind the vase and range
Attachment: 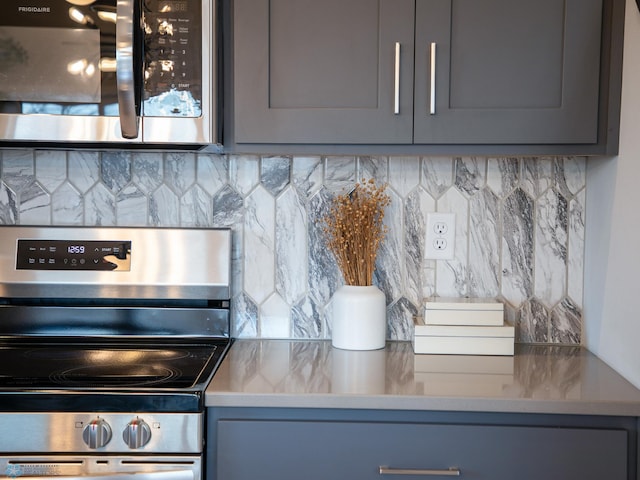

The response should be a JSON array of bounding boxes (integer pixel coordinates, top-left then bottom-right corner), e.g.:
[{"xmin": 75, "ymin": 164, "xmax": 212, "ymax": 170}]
[{"xmin": 0, "ymin": 150, "xmax": 586, "ymax": 344}]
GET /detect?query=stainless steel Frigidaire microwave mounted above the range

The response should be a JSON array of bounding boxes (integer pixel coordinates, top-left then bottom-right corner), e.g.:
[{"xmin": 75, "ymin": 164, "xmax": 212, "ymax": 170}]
[{"xmin": 0, "ymin": 0, "xmax": 218, "ymax": 148}]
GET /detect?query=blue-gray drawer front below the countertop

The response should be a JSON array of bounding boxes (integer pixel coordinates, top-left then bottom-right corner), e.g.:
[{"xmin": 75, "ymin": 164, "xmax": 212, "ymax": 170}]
[{"xmin": 215, "ymin": 420, "xmax": 627, "ymax": 480}]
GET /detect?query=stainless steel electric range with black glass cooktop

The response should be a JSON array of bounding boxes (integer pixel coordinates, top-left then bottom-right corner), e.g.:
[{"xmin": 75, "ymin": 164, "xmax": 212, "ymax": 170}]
[{"xmin": 0, "ymin": 226, "xmax": 231, "ymax": 480}]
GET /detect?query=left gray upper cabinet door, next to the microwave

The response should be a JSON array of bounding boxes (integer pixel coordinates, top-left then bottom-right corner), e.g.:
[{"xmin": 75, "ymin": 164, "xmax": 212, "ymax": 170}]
[{"xmin": 233, "ymin": 0, "xmax": 414, "ymax": 144}]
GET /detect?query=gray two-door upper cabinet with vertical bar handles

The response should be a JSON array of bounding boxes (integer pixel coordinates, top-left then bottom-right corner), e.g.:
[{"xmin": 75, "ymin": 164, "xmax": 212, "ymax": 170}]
[{"xmin": 225, "ymin": 0, "xmax": 624, "ymax": 154}]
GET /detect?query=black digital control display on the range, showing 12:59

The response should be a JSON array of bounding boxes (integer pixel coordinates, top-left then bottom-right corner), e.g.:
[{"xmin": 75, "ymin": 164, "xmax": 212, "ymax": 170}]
[{"xmin": 16, "ymin": 239, "xmax": 131, "ymax": 272}]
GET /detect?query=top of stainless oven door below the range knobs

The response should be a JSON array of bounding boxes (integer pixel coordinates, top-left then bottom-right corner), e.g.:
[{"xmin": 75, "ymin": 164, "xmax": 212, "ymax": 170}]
[{"xmin": 0, "ymin": 455, "xmax": 202, "ymax": 480}]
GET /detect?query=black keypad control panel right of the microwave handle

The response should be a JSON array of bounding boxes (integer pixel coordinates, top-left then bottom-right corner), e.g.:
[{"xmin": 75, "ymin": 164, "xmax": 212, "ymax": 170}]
[{"xmin": 142, "ymin": 0, "xmax": 203, "ymax": 117}]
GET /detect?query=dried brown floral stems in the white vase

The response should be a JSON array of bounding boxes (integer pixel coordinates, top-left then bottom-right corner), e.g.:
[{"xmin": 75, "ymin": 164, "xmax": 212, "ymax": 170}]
[{"xmin": 324, "ymin": 180, "xmax": 391, "ymax": 286}]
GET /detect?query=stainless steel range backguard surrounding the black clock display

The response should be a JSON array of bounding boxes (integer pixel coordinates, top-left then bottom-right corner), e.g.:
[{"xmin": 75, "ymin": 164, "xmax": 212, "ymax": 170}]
[{"xmin": 0, "ymin": 226, "xmax": 231, "ymax": 299}]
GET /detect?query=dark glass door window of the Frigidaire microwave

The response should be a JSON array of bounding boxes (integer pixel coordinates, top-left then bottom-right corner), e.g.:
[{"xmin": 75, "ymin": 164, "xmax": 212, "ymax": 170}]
[{"xmin": 0, "ymin": 0, "xmax": 125, "ymax": 116}]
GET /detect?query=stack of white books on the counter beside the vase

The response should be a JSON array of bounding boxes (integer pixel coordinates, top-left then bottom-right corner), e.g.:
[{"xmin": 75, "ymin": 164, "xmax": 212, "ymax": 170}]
[{"xmin": 412, "ymin": 298, "xmax": 515, "ymax": 355}]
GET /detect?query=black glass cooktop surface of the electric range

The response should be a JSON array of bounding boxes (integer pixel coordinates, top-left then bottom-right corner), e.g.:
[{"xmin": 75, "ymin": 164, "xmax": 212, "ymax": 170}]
[{"xmin": 0, "ymin": 340, "xmax": 228, "ymax": 391}]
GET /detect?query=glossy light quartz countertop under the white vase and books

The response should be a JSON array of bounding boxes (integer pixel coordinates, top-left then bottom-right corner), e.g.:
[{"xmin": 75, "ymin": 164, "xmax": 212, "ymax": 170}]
[{"xmin": 205, "ymin": 340, "xmax": 640, "ymax": 416}]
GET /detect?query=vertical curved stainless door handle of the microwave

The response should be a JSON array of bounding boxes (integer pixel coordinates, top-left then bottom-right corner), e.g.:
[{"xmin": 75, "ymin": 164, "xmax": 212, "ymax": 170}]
[{"xmin": 116, "ymin": 0, "xmax": 138, "ymax": 138}]
